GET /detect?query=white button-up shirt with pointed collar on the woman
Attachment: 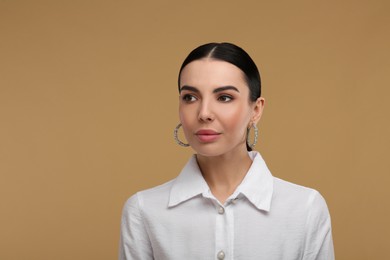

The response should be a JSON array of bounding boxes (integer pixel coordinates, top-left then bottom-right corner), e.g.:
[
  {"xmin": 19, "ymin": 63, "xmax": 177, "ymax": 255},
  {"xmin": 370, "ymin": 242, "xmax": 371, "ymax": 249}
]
[{"xmin": 119, "ymin": 152, "xmax": 334, "ymax": 260}]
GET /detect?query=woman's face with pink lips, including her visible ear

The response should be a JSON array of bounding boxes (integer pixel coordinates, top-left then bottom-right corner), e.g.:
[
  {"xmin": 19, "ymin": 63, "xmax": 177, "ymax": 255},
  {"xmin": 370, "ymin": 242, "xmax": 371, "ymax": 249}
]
[{"xmin": 179, "ymin": 58, "xmax": 264, "ymax": 156}]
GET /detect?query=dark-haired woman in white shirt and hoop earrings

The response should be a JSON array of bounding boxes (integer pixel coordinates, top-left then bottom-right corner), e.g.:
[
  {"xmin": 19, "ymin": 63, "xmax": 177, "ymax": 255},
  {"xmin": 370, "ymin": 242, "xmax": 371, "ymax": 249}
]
[{"xmin": 119, "ymin": 43, "xmax": 334, "ymax": 260}]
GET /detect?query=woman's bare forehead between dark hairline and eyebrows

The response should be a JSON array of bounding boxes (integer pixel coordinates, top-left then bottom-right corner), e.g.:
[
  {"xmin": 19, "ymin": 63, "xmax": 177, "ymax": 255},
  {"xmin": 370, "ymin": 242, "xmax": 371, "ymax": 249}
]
[{"xmin": 180, "ymin": 58, "xmax": 247, "ymax": 88}]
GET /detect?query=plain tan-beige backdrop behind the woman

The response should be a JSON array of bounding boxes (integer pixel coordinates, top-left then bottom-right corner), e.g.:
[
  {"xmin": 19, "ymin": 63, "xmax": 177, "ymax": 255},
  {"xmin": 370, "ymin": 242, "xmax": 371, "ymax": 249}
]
[{"xmin": 0, "ymin": 0, "xmax": 390, "ymax": 260}]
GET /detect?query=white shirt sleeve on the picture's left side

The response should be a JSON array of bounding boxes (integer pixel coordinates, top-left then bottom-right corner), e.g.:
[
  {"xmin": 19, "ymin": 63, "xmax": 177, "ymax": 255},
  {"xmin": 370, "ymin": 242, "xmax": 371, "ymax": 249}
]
[{"xmin": 119, "ymin": 194, "xmax": 153, "ymax": 260}]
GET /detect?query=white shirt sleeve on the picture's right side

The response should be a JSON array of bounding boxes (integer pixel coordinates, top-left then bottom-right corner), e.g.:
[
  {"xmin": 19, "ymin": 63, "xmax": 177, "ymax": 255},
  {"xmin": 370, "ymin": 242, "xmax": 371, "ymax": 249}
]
[{"xmin": 303, "ymin": 191, "xmax": 334, "ymax": 260}]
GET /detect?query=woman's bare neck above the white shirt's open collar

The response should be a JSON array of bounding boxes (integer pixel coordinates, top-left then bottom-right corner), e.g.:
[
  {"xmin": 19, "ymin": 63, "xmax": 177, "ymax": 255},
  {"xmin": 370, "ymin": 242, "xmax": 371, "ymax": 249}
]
[{"xmin": 196, "ymin": 147, "xmax": 252, "ymax": 204}]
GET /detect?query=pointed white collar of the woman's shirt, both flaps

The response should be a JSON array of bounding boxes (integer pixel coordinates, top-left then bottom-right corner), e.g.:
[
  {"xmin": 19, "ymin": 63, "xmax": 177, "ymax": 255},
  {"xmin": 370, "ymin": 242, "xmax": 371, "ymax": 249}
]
[{"xmin": 168, "ymin": 151, "xmax": 273, "ymax": 211}]
